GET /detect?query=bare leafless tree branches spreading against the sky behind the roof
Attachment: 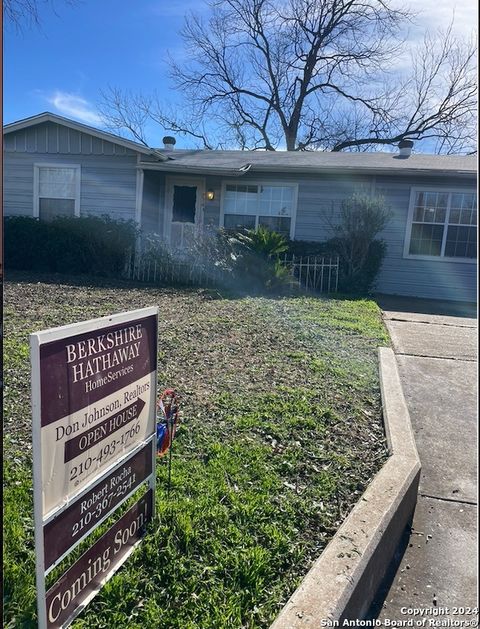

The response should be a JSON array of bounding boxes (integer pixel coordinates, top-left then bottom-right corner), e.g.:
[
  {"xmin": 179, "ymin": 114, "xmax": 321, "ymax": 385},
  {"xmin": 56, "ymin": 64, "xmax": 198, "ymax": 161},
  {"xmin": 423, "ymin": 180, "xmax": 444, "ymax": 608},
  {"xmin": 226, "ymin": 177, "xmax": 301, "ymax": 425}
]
[{"xmin": 101, "ymin": 0, "xmax": 476, "ymax": 152}]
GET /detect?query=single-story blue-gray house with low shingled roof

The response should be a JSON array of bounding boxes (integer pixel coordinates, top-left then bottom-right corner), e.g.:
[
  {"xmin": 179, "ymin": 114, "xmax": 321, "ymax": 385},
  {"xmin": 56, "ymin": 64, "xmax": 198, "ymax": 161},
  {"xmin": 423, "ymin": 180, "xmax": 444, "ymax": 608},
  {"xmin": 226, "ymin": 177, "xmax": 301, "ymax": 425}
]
[{"xmin": 3, "ymin": 113, "xmax": 477, "ymax": 301}]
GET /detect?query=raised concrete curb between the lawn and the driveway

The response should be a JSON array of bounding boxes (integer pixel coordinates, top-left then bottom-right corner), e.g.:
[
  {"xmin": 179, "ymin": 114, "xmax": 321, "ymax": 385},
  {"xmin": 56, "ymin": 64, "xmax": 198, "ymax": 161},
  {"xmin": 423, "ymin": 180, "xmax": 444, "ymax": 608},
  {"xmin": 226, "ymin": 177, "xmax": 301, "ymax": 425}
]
[{"xmin": 270, "ymin": 347, "xmax": 420, "ymax": 629}]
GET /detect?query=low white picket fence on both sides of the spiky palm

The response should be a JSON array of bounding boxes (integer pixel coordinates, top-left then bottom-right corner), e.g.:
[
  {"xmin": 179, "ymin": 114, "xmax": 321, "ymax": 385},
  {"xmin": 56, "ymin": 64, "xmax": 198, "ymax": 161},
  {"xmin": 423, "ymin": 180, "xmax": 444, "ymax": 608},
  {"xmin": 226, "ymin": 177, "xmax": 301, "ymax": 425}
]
[{"xmin": 125, "ymin": 250, "xmax": 339, "ymax": 293}]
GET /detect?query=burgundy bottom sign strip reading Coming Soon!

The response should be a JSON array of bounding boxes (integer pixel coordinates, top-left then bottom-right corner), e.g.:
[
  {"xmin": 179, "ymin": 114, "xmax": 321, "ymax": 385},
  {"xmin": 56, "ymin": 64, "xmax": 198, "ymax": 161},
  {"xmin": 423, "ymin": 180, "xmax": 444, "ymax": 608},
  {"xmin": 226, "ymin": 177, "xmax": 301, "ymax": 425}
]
[{"xmin": 46, "ymin": 490, "xmax": 153, "ymax": 629}]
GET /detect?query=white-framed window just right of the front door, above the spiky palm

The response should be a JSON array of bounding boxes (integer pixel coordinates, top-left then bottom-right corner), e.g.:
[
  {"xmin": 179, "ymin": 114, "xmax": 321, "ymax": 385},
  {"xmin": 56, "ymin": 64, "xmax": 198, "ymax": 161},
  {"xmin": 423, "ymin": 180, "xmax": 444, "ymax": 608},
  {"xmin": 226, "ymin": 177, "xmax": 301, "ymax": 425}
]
[{"xmin": 223, "ymin": 184, "xmax": 296, "ymax": 237}]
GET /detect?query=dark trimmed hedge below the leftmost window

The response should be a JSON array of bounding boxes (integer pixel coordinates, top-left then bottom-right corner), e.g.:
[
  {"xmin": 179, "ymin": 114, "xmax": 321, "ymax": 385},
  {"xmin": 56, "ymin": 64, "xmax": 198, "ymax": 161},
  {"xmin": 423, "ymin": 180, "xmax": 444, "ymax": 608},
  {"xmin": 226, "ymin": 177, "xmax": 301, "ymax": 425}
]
[{"xmin": 4, "ymin": 216, "xmax": 137, "ymax": 276}]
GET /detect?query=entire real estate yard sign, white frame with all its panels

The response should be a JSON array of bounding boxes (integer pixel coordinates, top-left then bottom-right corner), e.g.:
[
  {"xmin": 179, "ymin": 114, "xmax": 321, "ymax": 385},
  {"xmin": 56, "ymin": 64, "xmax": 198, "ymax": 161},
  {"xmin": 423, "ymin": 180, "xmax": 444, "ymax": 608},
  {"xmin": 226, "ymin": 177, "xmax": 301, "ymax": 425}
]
[{"xmin": 30, "ymin": 308, "xmax": 158, "ymax": 629}]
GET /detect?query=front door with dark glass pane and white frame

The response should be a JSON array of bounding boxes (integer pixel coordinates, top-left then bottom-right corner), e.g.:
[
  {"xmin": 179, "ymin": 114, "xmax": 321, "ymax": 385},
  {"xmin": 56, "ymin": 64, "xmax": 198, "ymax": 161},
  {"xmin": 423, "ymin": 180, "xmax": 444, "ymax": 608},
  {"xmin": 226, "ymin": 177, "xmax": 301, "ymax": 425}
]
[{"xmin": 165, "ymin": 177, "xmax": 205, "ymax": 249}]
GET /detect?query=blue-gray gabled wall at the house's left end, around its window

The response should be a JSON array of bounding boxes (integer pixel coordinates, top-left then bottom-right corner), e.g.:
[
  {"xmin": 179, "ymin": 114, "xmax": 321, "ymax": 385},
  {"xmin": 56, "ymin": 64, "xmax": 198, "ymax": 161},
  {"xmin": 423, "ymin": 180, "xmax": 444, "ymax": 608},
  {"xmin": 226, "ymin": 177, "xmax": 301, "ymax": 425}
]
[{"xmin": 4, "ymin": 123, "xmax": 137, "ymax": 220}]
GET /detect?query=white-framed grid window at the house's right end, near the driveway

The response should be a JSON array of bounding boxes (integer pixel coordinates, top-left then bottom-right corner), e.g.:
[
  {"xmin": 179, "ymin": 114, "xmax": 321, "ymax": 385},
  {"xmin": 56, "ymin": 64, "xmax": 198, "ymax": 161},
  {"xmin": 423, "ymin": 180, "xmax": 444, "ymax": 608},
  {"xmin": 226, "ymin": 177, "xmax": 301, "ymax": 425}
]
[{"xmin": 405, "ymin": 190, "xmax": 477, "ymax": 260}]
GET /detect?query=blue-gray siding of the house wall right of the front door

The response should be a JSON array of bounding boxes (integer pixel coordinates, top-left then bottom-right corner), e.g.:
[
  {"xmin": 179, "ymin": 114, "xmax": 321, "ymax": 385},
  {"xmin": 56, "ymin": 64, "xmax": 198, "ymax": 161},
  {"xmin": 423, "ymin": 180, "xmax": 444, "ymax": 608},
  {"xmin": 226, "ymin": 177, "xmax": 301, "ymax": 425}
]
[{"xmin": 211, "ymin": 173, "xmax": 477, "ymax": 301}]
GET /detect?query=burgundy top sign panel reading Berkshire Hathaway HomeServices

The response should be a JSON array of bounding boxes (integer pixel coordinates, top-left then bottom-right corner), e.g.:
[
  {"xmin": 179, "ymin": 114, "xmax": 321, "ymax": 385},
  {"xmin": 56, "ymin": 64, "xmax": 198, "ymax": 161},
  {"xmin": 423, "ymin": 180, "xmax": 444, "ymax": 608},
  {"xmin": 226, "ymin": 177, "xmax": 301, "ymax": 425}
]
[{"xmin": 40, "ymin": 316, "xmax": 157, "ymax": 426}]
